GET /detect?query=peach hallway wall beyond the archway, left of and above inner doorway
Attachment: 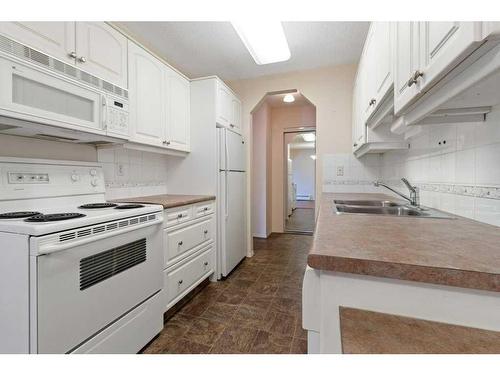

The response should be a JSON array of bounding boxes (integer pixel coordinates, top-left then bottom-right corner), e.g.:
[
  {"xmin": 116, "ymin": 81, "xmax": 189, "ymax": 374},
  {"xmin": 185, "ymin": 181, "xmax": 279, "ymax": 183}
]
[{"xmin": 271, "ymin": 105, "xmax": 316, "ymax": 233}]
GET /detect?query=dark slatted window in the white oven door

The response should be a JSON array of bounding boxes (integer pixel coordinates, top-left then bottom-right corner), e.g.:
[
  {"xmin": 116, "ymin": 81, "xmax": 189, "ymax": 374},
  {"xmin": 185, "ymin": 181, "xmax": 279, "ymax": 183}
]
[{"xmin": 80, "ymin": 238, "xmax": 146, "ymax": 290}]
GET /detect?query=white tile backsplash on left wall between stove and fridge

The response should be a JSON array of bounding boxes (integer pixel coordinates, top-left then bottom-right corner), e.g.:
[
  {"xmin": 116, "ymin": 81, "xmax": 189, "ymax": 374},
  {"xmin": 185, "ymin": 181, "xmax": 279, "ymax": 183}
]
[{"xmin": 97, "ymin": 148, "xmax": 167, "ymax": 199}]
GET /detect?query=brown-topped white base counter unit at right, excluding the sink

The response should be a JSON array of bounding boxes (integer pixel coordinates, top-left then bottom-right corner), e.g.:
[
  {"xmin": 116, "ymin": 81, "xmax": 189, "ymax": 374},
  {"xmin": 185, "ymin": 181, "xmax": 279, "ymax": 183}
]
[{"xmin": 303, "ymin": 193, "xmax": 500, "ymax": 353}]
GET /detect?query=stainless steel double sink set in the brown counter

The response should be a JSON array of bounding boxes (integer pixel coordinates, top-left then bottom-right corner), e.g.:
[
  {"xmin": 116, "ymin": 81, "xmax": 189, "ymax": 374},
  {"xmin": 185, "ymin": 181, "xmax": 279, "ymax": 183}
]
[{"xmin": 334, "ymin": 199, "xmax": 454, "ymax": 219}]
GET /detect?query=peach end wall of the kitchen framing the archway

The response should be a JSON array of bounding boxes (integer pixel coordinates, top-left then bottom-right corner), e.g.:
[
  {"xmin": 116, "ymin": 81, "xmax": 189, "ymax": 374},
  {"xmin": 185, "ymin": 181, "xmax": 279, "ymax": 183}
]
[{"xmin": 229, "ymin": 64, "xmax": 357, "ymax": 244}]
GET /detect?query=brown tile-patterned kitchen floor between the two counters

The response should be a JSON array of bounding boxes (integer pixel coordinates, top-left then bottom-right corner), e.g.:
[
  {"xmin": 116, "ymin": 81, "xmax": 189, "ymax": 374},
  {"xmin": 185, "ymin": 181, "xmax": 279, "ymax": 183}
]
[{"xmin": 143, "ymin": 234, "xmax": 312, "ymax": 354}]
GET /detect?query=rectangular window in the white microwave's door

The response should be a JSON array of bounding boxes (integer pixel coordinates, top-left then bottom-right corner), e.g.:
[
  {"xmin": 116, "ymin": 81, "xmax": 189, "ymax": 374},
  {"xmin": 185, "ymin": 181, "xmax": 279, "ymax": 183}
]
[{"xmin": 12, "ymin": 74, "xmax": 95, "ymax": 122}]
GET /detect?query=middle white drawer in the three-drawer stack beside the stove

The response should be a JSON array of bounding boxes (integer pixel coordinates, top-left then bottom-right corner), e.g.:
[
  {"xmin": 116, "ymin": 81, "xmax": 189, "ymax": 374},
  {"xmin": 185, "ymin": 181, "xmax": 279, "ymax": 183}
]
[{"xmin": 164, "ymin": 219, "xmax": 215, "ymax": 267}]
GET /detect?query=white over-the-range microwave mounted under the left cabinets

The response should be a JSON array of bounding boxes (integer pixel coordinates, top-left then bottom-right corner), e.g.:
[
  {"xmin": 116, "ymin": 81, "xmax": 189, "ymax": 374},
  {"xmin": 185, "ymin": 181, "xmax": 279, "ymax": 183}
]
[{"xmin": 0, "ymin": 42, "xmax": 129, "ymax": 142}]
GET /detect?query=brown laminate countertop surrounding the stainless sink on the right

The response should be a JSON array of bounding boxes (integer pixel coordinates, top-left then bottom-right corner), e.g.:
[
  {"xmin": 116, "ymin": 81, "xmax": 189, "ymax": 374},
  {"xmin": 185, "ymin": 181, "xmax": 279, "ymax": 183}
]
[{"xmin": 307, "ymin": 193, "xmax": 500, "ymax": 292}]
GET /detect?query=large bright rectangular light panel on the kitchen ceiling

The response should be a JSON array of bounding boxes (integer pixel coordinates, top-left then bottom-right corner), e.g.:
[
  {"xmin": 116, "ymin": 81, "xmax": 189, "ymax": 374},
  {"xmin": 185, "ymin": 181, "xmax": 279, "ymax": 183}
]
[{"xmin": 231, "ymin": 20, "xmax": 291, "ymax": 65}]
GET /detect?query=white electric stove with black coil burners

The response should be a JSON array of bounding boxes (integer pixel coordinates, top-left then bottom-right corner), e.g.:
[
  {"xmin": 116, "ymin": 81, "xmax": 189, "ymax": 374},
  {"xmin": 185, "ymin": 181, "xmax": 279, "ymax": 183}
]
[{"xmin": 0, "ymin": 158, "xmax": 163, "ymax": 353}]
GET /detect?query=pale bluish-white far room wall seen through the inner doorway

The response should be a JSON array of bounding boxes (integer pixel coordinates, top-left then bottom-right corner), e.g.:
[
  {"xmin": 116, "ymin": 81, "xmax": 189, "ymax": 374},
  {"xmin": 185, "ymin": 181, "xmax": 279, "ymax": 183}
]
[{"xmin": 291, "ymin": 149, "xmax": 316, "ymax": 200}]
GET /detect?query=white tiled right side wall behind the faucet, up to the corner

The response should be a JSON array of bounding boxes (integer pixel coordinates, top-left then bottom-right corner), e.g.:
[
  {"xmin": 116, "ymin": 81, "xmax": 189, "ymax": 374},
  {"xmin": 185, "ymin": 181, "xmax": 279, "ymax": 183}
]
[{"xmin": 381, "ymin": 107, "xmax": 500, "ymax": 226}]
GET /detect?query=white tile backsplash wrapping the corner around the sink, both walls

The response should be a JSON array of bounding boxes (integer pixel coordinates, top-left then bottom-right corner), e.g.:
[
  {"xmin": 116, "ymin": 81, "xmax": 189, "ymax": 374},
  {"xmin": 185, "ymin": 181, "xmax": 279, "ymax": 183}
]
[{"xmin": 323, "ymin": 107, "xmax": 500, "ymax": 226}]
